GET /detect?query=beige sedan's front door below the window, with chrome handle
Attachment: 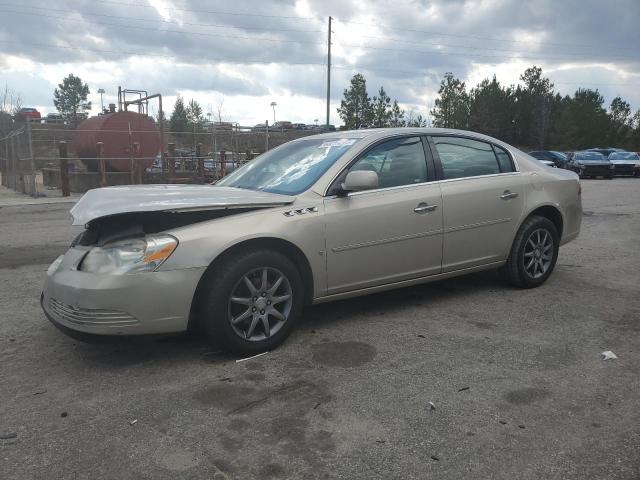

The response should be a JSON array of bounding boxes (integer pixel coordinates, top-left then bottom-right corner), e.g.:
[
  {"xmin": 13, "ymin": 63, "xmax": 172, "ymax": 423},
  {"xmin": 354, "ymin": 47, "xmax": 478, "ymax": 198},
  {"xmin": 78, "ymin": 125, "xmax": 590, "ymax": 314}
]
[{"xmin": 325, "ymin": 183, "xmax": 442, "ymax": 294}]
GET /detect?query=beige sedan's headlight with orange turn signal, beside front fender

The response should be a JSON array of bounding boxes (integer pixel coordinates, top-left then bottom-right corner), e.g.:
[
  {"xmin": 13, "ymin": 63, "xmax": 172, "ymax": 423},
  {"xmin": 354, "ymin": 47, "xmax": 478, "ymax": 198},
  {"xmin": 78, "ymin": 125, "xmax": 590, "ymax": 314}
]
[{"xmin": 80, "ymin": 235, "xmax": 178, "ymax": 275}]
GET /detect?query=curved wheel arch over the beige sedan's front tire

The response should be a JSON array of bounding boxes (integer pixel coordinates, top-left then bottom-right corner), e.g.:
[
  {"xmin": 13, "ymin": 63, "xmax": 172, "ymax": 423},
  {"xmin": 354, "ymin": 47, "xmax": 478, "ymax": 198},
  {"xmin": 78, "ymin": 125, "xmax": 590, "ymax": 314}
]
[{"xmin": 189, "ymin": 237, "xmax": 314, "ymax": 328}]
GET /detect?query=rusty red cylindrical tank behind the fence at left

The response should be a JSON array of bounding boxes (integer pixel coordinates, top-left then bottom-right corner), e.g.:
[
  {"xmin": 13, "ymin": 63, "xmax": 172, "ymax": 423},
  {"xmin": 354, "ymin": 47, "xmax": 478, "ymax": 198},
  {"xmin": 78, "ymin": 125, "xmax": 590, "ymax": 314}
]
[{"xmin": 71, "ymin": 112, "xmax": 160, "ymax": 172}]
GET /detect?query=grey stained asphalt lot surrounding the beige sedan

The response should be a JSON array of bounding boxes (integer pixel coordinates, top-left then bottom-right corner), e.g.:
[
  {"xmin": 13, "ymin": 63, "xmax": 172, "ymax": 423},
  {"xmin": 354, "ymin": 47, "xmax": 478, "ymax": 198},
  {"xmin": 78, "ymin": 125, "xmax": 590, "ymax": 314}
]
[{"xmin": 0, "ymin": 179, "xmax": 640, "ymax": 480}]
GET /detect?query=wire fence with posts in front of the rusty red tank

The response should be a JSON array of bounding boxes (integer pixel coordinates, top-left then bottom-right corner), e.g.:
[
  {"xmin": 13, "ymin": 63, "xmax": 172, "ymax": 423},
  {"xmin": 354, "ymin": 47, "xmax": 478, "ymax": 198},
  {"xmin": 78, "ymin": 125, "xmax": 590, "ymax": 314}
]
[{"xmin": 0, "ymin": 122, "xmax": 318, "ymax": 196}]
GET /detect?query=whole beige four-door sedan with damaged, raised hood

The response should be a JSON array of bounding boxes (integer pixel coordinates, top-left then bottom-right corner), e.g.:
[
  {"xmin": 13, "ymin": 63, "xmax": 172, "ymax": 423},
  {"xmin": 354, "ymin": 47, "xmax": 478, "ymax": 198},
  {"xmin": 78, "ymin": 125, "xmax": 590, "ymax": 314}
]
[{"xmin": 41, "ymin": 128, "xmax": 582, "ymax": 352}]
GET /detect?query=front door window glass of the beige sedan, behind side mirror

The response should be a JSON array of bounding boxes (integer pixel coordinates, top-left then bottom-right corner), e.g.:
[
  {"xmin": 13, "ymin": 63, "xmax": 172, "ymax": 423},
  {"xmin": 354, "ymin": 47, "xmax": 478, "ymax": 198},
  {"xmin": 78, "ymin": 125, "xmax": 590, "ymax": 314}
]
[{"xmin": 345, "ymin": 137, "xmax": 427, "ymax": 188}]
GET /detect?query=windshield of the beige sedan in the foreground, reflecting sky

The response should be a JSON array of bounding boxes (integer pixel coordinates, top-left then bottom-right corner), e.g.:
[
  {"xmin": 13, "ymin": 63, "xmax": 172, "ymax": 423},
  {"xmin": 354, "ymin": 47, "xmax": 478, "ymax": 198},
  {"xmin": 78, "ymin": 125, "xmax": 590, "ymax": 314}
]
[{"xmin": 217, "ymin": 138, "xmax": 358, "ymax": 195}]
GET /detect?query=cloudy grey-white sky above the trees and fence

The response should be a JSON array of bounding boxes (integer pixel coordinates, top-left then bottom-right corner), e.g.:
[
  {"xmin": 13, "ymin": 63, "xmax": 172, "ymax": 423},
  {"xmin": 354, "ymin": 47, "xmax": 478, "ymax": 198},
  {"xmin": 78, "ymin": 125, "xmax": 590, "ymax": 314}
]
[{"xmin": 0, "ymin": 0, "xmax": 640, "ymax": 125}]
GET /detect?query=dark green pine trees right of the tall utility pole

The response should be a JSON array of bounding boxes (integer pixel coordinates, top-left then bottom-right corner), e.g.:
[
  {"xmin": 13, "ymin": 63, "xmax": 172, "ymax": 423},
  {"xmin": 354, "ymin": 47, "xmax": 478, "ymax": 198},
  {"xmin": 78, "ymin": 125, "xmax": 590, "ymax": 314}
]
[{"xmin": 338, "ymin": 65, "xmax": 640, "ymax": 150}]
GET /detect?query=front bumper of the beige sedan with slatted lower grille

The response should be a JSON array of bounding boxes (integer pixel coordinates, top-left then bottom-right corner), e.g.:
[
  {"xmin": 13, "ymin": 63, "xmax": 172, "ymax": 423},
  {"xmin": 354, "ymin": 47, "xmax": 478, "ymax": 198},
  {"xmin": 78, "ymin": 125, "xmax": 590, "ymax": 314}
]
[{"xmin": 41, "ymin": 247, "xmax": 205, "ymax": 335}]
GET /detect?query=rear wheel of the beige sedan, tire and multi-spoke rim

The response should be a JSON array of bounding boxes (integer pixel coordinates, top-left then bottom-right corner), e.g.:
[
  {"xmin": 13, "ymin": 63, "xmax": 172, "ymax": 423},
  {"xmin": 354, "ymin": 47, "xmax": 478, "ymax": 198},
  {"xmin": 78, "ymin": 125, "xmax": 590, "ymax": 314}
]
[{"xmin": 502, "ymin": 215, "xmax": 560, "ymax": 288}]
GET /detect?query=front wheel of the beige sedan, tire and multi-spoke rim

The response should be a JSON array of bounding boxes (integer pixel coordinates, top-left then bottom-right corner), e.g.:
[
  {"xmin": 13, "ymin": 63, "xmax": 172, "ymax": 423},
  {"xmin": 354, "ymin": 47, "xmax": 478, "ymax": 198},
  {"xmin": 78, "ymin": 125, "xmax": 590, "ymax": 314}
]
[{"xmin": 199, "ymin": 250, "xmax": 304, "ymax": 354}]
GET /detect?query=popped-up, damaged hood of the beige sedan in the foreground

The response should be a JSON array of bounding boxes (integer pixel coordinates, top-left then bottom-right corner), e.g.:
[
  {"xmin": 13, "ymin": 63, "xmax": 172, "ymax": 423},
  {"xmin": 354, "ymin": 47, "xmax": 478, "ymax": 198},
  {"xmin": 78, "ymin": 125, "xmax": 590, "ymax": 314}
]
[{"xmin": 71, "ymin": 185, "xmax": 296, "ymax": 225}]
